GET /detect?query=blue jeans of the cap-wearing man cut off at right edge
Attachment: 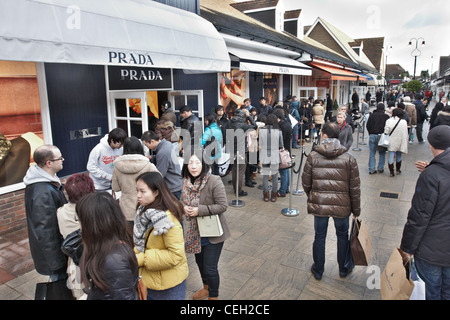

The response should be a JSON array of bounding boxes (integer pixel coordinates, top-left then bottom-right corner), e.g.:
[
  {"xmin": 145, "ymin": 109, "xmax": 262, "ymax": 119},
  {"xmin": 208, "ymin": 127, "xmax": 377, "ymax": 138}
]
[{"xmin": 414, "ymin": 256, "xmax": 450, "ymax": 300}]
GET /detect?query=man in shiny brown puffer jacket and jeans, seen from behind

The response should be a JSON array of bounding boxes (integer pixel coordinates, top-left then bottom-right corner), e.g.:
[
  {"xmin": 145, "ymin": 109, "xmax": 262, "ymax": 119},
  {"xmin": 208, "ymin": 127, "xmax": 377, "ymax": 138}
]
[{"xmin": 302, "ymin": 122, "xmax": 361, "ymax": 280}]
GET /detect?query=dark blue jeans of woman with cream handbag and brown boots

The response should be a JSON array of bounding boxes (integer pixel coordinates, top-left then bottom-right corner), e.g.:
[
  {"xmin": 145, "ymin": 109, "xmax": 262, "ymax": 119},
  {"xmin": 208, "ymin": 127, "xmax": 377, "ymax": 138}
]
[{"xmin": 195, "ymin": 241, "xmax": 223, "ymax": 298}]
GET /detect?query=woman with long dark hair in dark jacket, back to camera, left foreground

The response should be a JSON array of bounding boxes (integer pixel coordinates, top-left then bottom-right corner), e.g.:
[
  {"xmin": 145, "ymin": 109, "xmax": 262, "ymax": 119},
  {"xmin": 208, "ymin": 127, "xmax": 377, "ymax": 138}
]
[{"xmin": 76, "ymin": 192, "xmax": 139, "ymax": 300}]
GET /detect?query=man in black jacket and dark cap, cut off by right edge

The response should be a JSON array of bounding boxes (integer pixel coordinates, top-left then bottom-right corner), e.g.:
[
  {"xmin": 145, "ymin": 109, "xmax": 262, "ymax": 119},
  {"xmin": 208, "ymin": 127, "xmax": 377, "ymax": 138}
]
[{"xmin": 400, "ymin": 125, "xmax": 450, "ymax": 300}]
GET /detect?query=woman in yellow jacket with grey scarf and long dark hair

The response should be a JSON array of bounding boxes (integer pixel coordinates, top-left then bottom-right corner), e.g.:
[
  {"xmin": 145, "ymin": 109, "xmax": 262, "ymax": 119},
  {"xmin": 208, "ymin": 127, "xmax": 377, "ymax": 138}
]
[{"xmin": 133, "ymin": 172, "xmax": 189, "ymax": 300}]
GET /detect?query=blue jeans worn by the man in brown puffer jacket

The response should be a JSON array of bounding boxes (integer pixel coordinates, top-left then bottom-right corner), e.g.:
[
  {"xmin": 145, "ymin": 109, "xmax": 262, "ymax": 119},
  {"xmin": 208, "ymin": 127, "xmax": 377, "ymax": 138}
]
[{"xmin": 313, "ymin": 216, "xmax": 349, "ymax": 277}]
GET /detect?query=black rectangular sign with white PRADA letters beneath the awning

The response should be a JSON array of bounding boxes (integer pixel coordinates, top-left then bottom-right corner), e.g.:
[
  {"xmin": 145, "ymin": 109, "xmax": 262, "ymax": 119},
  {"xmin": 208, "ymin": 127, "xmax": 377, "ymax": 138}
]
[{"xmin": 108, "ymin": 66, "xmax": 172, "ymax": 90}]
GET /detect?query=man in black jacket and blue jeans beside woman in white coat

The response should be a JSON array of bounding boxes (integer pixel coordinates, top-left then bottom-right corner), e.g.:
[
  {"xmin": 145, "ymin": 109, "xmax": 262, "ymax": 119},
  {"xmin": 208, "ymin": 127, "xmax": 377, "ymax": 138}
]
[{"xmin": 366, "ymin": 102, "xmax": 389, "ymax": 174}]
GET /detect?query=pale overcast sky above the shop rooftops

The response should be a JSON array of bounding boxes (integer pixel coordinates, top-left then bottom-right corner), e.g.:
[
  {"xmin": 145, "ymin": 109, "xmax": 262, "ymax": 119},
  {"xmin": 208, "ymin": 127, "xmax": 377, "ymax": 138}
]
[{"xmin": 283, "ymin": 0, "xmax": 450, "ymax": 75}]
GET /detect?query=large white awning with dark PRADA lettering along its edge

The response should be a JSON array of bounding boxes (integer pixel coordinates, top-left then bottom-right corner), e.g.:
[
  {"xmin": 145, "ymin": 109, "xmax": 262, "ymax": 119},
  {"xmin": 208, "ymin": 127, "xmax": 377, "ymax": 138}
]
[{"xmin": 0, "ymin": 0, "xmax": 230, "ymax": 71}]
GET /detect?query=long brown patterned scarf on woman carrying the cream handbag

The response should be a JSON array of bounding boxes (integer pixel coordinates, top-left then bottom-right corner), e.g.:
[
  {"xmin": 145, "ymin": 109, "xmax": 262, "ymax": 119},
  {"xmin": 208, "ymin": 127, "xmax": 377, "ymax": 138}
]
[{"xmin": 180, "ymin": 172, "xmax": 211, "ymax": 254}]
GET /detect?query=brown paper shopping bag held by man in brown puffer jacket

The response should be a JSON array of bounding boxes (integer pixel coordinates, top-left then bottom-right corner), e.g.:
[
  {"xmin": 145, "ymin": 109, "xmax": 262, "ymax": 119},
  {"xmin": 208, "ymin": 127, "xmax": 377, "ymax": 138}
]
[{"xmin": 350, "ymin": 219, "xmax": 372, "ymax": 266}]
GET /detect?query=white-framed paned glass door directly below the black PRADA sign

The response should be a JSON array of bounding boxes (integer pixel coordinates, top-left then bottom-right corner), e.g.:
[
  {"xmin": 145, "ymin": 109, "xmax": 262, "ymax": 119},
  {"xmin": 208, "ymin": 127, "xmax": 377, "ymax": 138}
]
[{"xmin": 108, "ymin": 92, "xmax": 148, "ymax": 139}]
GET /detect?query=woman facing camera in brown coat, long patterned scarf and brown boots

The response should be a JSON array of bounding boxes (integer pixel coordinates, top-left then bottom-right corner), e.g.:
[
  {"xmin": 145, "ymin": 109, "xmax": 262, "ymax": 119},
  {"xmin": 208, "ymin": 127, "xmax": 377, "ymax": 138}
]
[{"xmin": 181, "ymin": 152, "xmax": 230, "ymax": 300}]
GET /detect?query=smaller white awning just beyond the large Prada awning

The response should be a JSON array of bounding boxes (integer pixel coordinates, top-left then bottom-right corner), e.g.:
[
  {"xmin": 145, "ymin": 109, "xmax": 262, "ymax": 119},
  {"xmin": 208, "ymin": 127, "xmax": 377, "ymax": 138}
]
[{"xmin": 228, "ymin": 45, "xmax": 312, "ymax": 76}]
